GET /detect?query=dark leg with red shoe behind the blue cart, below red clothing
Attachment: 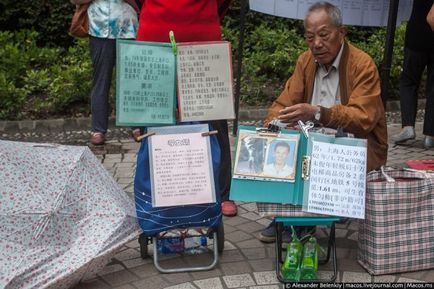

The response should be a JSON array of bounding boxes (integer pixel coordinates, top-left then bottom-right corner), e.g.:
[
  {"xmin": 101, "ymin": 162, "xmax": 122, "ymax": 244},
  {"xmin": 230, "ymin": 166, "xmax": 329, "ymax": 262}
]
[{"xmin": 211, "ymin": 120, "xmax": 237, "ymax": 216}]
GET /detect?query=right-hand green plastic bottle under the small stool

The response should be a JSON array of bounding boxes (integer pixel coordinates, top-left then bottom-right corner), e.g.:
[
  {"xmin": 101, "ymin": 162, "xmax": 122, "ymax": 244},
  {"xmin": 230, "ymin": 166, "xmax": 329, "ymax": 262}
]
[{"xmin": 300, "ymin": 237, "xmax": 319, "ymax": 280}]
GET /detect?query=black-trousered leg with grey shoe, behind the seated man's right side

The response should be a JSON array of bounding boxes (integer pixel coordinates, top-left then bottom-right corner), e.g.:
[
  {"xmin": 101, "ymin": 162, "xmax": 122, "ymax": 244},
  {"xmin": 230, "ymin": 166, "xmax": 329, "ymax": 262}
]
[{"xmin": 393, "ymin": 48, "xmax": 427, "ymax": 143}]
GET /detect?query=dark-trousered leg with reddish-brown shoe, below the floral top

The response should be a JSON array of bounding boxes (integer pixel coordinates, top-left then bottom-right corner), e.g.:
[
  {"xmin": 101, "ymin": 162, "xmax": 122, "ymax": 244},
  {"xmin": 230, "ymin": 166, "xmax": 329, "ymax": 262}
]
[{"xmin": 89, "ymin": 36, "xmax": 116, "ymax": 145}]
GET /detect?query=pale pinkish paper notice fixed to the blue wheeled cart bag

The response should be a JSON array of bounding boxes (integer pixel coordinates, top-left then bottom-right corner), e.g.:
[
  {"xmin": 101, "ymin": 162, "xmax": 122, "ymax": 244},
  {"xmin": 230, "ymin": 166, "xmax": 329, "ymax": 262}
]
[{"xmin": 151, "ymin": 133, "xmax": 215, "ymax": 207}]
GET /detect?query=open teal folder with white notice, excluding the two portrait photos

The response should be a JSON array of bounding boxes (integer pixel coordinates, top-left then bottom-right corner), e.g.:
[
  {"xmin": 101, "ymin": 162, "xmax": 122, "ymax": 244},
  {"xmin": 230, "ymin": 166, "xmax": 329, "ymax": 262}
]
[{"xmin": 230, "ymin": 124, "xmax": 367, "ymax": 219}]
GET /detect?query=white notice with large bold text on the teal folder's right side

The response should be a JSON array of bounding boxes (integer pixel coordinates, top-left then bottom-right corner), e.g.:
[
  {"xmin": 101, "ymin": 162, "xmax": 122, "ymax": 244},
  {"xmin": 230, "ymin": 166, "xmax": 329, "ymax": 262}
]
[{"xmin": 306, "ymin": 141, "xmax": 366, "ymax": 219}]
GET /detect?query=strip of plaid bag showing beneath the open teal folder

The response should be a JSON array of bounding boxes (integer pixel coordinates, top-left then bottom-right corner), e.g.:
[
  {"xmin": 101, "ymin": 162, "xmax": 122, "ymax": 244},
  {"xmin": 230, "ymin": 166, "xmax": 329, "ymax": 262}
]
[{"xmin": 256, "ymin": 202, "xmax": 324, "ymax": 217}]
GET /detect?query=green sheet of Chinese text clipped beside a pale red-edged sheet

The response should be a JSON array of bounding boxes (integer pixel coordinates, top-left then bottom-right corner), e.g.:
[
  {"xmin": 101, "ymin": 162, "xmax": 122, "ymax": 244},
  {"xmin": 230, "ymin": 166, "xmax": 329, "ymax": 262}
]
[{"xmin": 116, "ymin": 40, "xmax": 176, "ymax": 126}]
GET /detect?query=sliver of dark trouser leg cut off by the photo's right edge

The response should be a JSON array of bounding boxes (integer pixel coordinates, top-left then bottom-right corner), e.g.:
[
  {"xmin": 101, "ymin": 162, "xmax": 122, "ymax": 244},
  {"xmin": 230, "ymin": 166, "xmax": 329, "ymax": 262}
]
[{"xmin": 423, "ymin": 51, "xmax": 434, "ymax": 149}]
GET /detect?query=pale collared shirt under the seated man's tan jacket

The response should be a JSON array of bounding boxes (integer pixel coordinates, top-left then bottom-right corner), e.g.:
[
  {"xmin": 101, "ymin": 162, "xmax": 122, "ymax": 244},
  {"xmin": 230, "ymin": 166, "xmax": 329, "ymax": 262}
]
[{"xmin": 311, "ymin": 44, "xmax": 344, "ymax": 108}]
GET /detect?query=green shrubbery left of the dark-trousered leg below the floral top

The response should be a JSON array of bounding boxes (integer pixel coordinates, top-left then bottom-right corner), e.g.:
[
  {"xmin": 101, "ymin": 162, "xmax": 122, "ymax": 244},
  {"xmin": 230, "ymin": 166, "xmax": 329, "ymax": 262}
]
[{"xmin": 0, "ymin": 31, "xmax": 91, "ymax": 119}]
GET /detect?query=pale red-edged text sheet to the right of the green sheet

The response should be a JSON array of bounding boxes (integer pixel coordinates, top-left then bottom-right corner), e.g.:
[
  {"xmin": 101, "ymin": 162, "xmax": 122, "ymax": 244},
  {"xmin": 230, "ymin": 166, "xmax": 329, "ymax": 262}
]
[{"xmin": 177, "ymin": 42, "xmax": 235, "ymax": 122}]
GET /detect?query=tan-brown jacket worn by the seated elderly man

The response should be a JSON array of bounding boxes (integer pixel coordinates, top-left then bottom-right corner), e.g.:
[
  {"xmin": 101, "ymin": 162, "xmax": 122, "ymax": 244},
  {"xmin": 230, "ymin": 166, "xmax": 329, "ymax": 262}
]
[{"xmin": 265, "ymin": 43, "xmax": 388, "ymax": 171}]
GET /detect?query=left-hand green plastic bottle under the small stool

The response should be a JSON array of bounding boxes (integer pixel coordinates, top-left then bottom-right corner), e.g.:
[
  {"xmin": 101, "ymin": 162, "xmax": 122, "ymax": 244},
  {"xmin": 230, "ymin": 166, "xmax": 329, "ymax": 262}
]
[{"xmin": 281, "ymin": 228, "xmax": 303, "ymax": 281}]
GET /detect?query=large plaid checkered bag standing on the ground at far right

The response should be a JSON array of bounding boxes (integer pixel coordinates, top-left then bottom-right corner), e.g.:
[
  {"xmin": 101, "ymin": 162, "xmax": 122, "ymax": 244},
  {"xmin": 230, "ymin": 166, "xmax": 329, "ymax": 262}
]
[{"xmin": 357, "ymin": 169, "xmax": 434, "ymax": 275}]
